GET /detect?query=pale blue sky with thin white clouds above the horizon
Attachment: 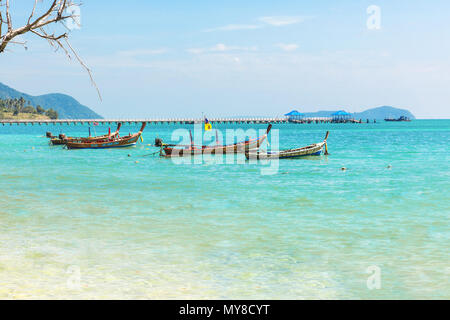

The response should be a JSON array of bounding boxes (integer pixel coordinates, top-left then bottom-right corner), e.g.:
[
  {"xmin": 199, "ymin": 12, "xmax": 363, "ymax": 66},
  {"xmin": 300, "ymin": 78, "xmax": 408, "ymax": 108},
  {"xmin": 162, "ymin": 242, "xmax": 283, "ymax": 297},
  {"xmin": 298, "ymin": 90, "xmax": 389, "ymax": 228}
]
[{"xmin": 0, "ymin": 0, "xmax": 450, "ymax": 118}]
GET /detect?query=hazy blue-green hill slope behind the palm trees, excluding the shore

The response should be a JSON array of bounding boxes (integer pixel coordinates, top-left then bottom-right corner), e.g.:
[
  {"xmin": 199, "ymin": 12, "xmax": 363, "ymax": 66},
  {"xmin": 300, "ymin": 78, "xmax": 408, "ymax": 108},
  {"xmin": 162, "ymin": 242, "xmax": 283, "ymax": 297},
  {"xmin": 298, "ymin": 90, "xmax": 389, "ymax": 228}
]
[{"xmin": 0, "ymin": 82, "xmax": 103, "ymax": 119}]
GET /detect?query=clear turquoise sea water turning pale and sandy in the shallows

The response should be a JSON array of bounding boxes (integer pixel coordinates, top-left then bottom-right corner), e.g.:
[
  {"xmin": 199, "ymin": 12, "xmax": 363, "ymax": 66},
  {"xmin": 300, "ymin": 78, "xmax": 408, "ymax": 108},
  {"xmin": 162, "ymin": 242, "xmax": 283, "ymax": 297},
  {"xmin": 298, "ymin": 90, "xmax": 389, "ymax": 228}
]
[{"xmin": 0, "ymin": 120, "xmax": 450, "ymax": 299}]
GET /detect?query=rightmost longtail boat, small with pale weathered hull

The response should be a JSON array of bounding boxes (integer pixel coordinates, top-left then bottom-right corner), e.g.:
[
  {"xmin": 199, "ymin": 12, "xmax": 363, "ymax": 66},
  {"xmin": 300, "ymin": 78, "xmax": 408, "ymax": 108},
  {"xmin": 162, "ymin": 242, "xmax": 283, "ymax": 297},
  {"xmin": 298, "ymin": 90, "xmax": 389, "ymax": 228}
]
[{"xmin": 245, "ymin": 131, "xmax": 330, "ymax": 160}]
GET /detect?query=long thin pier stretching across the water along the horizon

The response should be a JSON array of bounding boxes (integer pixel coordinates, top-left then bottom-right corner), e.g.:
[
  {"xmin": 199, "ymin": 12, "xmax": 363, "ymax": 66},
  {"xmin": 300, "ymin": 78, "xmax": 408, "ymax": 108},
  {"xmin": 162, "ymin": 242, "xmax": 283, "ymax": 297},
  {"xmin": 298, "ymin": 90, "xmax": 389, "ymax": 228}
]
[{"xmin": 0, "ymin": 117, "xmax": 372, "ymax": 126}]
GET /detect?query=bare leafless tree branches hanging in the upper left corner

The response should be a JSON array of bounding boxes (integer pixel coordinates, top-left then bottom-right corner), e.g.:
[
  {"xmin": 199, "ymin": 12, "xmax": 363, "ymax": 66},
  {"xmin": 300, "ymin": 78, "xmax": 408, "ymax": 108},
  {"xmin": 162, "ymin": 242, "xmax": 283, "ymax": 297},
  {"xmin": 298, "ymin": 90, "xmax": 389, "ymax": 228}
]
[{"xmin": 0, "ymin": 0, "xmax": 102, "ymax": 100}]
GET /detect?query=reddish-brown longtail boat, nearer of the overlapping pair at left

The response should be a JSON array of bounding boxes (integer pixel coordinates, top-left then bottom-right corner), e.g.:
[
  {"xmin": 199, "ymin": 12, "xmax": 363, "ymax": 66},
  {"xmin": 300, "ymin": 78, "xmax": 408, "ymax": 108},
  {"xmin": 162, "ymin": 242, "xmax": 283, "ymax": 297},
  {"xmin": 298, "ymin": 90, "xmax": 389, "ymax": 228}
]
[{"xmin": 66, "ymin": 122, "xmax": 147, "ymax": 149}]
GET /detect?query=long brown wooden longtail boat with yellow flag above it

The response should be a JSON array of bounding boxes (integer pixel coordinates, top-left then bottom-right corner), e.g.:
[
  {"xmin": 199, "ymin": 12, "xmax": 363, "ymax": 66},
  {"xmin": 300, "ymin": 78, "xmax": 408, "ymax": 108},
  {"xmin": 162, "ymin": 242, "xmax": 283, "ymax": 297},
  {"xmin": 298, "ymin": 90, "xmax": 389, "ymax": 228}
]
[{"xmin": 160, "ymin": 124, "xmax": 272, "ymax": 157}]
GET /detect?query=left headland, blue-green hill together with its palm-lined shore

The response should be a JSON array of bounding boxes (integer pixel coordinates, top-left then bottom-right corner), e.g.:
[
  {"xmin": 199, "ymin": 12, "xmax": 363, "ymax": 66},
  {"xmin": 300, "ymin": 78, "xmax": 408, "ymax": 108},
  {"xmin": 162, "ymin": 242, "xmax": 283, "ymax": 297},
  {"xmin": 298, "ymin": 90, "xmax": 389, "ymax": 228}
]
[{"xmin": 0, "ymin": 82, "xmax": 103, "ymax": 119}]
